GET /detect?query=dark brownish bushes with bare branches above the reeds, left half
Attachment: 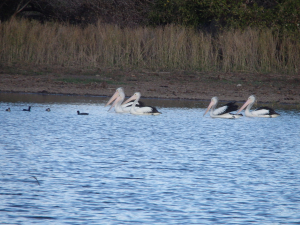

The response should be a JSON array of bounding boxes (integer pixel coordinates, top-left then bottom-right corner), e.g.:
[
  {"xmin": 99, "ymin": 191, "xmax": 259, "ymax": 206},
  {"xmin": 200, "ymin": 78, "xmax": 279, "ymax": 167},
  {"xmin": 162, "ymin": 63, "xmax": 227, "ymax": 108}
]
[{"xmin": 0, "ymin": 0, "xmax": 153, "ymax": 27}]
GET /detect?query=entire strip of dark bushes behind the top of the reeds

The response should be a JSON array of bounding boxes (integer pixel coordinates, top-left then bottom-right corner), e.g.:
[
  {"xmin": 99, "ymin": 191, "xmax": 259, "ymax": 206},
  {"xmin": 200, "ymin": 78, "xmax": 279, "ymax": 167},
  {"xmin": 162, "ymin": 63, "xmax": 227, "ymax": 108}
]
[{"xmin": 0, "ymin": 0, "xmax": 300, "ymax": 32}]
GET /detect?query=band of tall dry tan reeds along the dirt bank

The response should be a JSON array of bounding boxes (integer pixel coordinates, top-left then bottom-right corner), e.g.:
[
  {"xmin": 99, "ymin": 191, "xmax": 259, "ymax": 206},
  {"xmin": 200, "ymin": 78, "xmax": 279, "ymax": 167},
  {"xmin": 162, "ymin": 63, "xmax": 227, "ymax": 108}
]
[{"xmin": 0, "ymin": 19, "xmax": 300, "ymax": 73}]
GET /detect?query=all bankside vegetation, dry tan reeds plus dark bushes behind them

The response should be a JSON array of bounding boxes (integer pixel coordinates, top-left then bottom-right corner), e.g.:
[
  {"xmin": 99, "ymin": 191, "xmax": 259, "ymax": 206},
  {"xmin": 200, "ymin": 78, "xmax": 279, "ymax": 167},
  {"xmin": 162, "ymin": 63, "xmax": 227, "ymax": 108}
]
[{"xmin": 0, "ymin": 0, "xmax": 300, "ymax": 73}]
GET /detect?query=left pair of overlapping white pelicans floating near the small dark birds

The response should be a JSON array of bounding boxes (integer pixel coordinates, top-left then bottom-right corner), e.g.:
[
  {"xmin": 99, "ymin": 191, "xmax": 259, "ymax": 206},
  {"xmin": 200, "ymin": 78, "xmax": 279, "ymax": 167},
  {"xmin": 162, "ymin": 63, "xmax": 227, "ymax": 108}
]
[{"xmin": 105, "ymin": 87, "xmax": 161, "ymax": 115}]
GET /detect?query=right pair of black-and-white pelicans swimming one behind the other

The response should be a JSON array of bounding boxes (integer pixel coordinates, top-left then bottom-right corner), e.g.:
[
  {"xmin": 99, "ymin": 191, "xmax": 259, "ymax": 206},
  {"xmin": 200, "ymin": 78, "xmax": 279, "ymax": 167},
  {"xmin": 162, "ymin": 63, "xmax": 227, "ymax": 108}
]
[{"xmin": 203, "ymin": 95, "xmax": 280, "ymax": 119}]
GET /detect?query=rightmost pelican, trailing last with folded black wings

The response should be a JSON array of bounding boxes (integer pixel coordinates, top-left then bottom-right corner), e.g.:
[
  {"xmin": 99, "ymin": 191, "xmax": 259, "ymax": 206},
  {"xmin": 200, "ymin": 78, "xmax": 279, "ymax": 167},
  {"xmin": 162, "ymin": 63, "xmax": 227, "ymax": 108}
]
[{"xmin": 237, "ymin": 95, "xmax": 280, "ymax": 118}]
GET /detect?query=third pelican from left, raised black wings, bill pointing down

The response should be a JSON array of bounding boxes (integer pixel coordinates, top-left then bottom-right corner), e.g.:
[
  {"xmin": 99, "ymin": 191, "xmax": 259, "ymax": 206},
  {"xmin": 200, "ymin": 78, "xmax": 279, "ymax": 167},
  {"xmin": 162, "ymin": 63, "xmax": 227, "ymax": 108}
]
[{"xmin": 203, "ymin": 97, "xmax": 243, "ymax": 119}]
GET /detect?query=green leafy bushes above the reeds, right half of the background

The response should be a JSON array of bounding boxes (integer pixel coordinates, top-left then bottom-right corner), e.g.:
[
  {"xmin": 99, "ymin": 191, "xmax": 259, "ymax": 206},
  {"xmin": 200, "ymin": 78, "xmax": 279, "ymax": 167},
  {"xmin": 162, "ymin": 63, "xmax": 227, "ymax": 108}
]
[{"xmin": 149, "ymin": 0, "xmax": 300, "ymax": 32}]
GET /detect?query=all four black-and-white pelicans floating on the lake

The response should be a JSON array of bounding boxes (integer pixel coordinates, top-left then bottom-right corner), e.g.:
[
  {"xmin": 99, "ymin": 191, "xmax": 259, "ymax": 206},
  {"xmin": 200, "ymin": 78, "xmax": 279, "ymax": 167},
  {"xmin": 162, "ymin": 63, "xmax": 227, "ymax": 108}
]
[{"xmin": 105, "ymin": 87, "xmax": 280, "ymax": 119}]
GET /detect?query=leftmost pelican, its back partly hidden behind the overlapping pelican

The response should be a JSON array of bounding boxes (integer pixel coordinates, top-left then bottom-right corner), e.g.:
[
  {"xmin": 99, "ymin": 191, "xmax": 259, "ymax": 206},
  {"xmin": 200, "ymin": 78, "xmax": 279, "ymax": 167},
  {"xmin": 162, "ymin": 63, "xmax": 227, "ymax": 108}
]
[{"xmin": 105, "ymin": 87, "xmax": 144, "ymax": 113}]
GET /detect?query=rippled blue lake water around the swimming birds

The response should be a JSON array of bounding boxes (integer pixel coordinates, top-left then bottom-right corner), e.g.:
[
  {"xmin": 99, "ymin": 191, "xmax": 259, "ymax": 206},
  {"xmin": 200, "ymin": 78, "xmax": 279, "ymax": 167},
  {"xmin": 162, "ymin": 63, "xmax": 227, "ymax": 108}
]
[{"xmin": 0, "ymin": 93, "xmax": 300, "ymax": 224}]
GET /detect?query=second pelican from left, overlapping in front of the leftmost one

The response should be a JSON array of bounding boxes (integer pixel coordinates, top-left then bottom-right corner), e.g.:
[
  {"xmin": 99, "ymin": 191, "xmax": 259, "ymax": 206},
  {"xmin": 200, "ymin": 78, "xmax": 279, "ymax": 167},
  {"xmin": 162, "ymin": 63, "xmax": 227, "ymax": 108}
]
[{"xmin": 122, "ymin": 92, "xmax": 161, "ymax": 115}]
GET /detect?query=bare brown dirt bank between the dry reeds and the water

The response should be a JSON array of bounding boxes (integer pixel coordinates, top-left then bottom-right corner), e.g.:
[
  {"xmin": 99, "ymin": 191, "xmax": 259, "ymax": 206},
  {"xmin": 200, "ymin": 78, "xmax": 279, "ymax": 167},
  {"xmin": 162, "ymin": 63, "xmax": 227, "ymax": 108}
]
[{"xmin": 0, "ymin": 71, "xmax": 300, "ymax": 104}]
